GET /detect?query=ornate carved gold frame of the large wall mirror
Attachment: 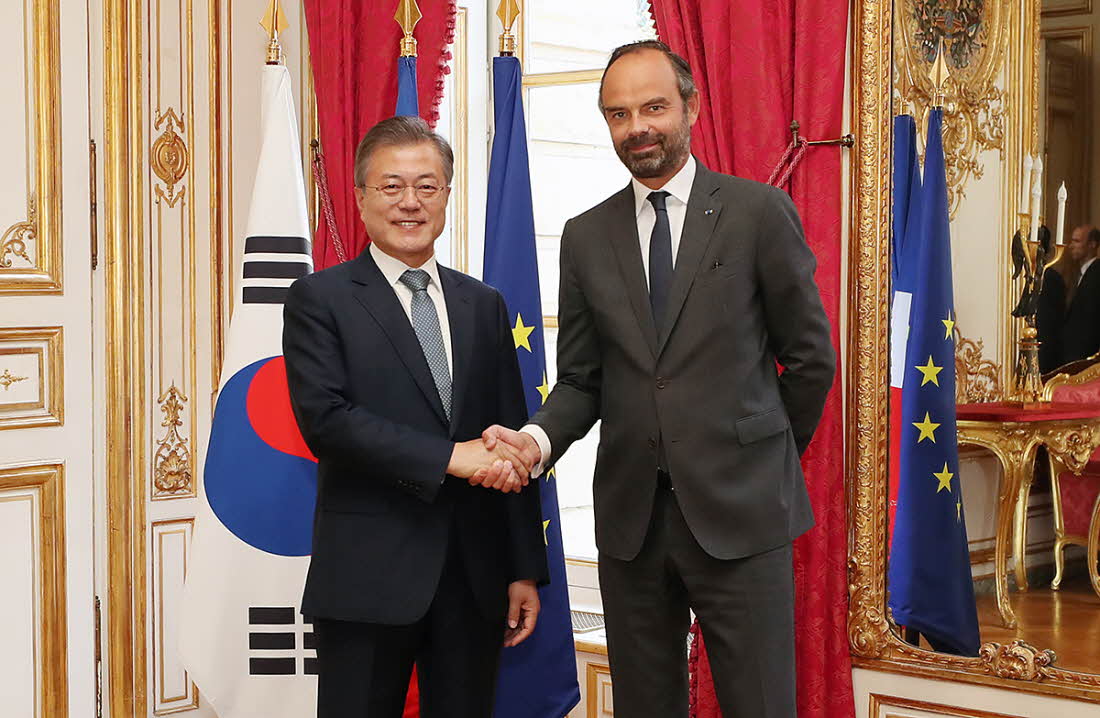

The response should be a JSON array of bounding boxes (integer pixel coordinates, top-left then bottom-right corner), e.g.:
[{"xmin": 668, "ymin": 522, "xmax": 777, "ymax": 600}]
[{"xmin": 847, "ymin": 0, "xmax": 1100, "ymax": 702}]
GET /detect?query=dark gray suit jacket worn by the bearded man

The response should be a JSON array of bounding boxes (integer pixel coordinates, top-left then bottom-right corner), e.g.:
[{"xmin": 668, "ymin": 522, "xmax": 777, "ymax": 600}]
[{"xmin": 531, "ymin": 164, "xmax": 836, "ymax": 560}]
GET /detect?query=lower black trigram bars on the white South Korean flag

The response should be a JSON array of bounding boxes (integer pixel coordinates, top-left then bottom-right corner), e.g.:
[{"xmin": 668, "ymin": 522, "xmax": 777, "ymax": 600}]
[{"xmin": 249, "ymin": 606, "xmax": 317, "ymax": 675}]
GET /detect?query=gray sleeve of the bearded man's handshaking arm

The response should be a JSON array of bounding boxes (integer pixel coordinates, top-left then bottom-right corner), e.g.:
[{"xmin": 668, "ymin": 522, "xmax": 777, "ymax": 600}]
[{"xmin": 531, "ymin": 220, "xmax": 603, "ymax": 468}]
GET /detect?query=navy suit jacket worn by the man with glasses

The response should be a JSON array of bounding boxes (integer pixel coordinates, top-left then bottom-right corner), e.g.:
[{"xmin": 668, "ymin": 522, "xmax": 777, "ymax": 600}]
[{"xmin": 283, "ymin": 251, "xmax": 548, "ymax": 625}]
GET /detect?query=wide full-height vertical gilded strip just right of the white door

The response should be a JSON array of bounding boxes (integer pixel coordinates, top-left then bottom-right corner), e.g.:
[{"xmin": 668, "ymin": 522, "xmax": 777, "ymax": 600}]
[{"xmin": 101, "ymin": 0, "xmax": 147, "ymax": 718}]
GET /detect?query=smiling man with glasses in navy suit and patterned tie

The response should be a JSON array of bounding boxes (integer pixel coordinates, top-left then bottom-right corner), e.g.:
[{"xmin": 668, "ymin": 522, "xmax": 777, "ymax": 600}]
[{"xmin": 283, "ymin": 117, "xmax": 548, "ymax": 718}]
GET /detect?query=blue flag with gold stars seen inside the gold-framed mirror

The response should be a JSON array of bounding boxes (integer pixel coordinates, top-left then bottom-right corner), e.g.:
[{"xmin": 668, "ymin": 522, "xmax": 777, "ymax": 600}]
[{"xmin": 889, "ymin": 108, "xmax": 980, "ymax": 655}]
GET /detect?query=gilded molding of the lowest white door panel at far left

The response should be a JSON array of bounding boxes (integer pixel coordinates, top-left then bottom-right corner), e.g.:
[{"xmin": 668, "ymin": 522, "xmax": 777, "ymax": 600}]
[{"xmin": 0, "ymin": 463, "xmax": 69, "ymax": 717}]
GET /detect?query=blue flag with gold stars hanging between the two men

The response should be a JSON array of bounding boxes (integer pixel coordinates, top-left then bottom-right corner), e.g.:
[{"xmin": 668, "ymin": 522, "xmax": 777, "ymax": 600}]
[{"xmin": 484, "ymin": 57, "xmax": 581, "ymax": 718}]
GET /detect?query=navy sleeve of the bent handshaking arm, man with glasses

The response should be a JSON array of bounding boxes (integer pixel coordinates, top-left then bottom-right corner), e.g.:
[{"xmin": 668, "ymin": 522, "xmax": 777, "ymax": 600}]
[{"xmin": 283, "ymin": 280, "xmax": 454, "ymax": 502}]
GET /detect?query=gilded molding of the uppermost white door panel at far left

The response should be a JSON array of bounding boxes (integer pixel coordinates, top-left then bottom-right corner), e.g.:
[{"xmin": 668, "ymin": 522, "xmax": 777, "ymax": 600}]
[{"xmin": 0, "ymin": 0, "xmax": 62, "ymax": 295}]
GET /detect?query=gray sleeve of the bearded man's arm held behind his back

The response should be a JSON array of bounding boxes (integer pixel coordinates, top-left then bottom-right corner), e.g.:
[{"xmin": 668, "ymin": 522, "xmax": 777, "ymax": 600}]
[{"xmin": 757, "ymin": 189, "xmax": 836, "ymax": 454}]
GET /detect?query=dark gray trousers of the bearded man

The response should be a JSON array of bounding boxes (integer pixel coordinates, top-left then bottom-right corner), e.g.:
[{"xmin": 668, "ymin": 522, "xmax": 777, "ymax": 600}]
[{"xmin": 600, "ymin": 488, "xmax": 796, "ymax": 718}]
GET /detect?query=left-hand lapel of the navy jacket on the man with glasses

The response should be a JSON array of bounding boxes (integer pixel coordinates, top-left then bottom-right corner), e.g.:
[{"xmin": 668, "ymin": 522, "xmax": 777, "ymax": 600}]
[{"xmin": 351, "ymin": 250, "xmax": 444, "ymax": 426}]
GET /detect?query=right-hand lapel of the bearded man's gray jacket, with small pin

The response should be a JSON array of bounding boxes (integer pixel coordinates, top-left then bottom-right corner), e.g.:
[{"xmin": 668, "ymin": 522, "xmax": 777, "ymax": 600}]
[{"xmin": 655, "ymin": 163, "xmax": 722, "ymax": 355}]
